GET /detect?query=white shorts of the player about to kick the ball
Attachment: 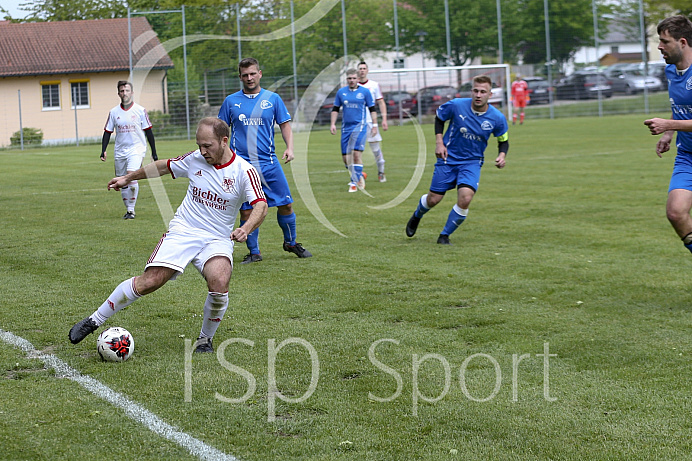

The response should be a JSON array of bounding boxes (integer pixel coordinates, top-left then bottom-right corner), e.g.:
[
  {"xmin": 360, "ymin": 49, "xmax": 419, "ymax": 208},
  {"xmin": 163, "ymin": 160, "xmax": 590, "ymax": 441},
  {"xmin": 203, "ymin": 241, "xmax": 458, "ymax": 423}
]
[{"xmin": 144, "ymin": 229, "xmax": 235, "ymax": 280}]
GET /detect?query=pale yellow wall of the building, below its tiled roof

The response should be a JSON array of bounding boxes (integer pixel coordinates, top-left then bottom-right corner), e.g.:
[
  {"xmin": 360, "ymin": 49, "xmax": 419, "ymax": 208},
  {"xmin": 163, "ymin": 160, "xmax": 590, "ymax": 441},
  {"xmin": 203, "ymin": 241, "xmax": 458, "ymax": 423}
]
[{"xmin": 0, "ymin": 70, "xmax": 167, "ymax": 147}]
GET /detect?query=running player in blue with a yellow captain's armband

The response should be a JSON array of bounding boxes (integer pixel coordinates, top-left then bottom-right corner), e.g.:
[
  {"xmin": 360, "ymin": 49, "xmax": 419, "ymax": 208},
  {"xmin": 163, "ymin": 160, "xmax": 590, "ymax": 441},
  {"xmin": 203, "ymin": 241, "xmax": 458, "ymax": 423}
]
[{"xmin": 406, "ymin": 75, "xmax": 509, "ymax": 245}]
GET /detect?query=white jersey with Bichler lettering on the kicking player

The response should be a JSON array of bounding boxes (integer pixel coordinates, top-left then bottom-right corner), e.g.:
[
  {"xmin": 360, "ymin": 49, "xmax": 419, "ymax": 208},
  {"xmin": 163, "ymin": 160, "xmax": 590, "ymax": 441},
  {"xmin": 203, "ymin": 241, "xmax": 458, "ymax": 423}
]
[{"xmin": 168, "ymin": 149, "xmax": 267, "ymax": 238}]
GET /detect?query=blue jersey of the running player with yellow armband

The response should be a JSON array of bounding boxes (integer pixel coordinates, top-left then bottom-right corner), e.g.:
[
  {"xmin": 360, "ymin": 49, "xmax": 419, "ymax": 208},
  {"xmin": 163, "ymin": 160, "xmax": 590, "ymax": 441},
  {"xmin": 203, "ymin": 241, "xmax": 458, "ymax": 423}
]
[{"xmin": 437, "ymin": 98, "xmax": 508, "ymax": 165}]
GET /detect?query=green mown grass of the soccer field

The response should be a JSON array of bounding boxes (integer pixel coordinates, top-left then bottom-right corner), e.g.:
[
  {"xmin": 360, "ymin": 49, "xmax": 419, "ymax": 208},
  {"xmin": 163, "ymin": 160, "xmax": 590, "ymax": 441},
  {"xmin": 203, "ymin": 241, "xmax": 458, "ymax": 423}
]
[{"xmin": 0, "ymin": 115, "xmax": 692, "ymax": 460}]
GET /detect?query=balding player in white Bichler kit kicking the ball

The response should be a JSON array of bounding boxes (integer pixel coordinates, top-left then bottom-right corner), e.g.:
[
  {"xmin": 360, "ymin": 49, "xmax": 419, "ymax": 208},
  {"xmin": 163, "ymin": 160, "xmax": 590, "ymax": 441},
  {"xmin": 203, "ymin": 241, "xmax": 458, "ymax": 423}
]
[{"xmin": 69, "ymin": 117, "xmax": 267, "ymax": 352}]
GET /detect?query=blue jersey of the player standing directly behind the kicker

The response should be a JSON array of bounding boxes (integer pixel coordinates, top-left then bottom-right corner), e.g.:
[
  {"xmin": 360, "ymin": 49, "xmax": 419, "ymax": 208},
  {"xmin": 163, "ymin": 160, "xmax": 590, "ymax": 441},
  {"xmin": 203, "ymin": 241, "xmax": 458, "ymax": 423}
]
[{"xmin": 219, "ymin": 89, "xmax": 291, "ymax": 165}]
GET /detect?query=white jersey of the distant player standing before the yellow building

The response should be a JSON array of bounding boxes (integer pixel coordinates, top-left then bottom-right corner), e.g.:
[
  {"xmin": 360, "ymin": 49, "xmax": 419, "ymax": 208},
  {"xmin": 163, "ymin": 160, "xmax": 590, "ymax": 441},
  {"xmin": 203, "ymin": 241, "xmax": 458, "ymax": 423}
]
[{"xmin": 103, "ymin": 103, "xmax": 151, "ymax": 158}]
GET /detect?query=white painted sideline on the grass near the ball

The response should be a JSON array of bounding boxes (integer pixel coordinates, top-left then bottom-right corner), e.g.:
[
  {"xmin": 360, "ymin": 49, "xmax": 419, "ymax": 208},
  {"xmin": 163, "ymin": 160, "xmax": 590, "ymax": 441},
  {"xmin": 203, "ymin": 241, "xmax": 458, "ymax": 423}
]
[{"xmin": 0, "ymin": 329, "xmax": 238, "ymax": 461}]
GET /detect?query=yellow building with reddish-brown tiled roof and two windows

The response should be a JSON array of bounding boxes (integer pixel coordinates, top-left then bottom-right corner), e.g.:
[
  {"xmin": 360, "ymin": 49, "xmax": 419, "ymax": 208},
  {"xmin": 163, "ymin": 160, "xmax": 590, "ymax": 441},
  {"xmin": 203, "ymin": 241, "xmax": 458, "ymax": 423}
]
[{"xmin": 0, "ymin": 17, "xmax": 173, "ymax": 146}]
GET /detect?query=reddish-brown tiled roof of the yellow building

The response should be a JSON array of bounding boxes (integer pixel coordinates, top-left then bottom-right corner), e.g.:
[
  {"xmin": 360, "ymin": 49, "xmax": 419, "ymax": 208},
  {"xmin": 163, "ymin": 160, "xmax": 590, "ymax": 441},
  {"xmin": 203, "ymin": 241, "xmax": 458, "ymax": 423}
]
[{"xmin": 0, "ymin": 17, "xmax": 173, "ymax": 77}]
